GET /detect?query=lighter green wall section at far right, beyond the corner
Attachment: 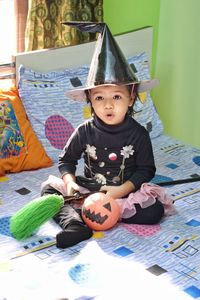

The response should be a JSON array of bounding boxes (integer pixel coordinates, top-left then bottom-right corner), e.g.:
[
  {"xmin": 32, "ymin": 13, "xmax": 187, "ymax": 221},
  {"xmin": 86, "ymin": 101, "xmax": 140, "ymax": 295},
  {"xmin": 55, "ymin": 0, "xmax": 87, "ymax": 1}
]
[{"xmin": 153, "ymin": 0, "xmax": 200, "ymax": 147}]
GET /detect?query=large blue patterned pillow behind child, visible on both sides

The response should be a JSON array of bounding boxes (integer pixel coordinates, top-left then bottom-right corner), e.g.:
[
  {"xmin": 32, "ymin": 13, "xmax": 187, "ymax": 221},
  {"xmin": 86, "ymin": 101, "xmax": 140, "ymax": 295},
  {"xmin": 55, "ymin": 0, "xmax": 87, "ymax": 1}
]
[{"xmin": 19, "ymin": 53, "xmax": 162, "ymax": 162}]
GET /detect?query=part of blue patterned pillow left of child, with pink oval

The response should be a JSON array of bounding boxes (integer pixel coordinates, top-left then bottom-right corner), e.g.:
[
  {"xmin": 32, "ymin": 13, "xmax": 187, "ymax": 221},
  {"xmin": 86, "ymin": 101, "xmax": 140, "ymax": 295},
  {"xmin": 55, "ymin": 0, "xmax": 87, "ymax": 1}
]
[{"xmin": 19, "ymin": 66, "xmax": 91, "ymax": 162}]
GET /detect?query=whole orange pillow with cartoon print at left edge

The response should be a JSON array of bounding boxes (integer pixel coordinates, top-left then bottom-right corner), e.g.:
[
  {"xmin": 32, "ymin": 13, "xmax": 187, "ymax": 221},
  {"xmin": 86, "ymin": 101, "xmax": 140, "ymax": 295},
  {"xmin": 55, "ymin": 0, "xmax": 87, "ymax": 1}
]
[{"xmin": 0, "ymin": 87, "xmax": 52, "ymax": 176}]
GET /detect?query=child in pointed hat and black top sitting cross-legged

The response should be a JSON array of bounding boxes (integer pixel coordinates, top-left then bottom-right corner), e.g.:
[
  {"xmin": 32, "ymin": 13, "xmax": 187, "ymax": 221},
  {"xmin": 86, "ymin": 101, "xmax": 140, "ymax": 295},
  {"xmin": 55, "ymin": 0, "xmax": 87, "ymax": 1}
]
[{"xmin": 42, "ymin": 23, "xmax": 173, "ymax": 248}]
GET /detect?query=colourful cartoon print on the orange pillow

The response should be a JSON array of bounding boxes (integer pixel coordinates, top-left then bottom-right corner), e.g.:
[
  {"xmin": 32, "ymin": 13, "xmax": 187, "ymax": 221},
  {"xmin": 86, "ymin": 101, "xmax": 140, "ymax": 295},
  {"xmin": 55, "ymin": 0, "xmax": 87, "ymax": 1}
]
[{"xmin": 0, "ymin": 100, "xmax": 26, "ymax": 159}]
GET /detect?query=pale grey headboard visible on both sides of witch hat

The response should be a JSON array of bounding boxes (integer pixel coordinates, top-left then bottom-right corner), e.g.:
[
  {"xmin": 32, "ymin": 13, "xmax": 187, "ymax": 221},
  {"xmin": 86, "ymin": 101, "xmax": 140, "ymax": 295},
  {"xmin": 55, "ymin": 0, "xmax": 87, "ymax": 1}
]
[{"xmin": 15, "ymin": 27, "xmax": 153, "ymax": 82}]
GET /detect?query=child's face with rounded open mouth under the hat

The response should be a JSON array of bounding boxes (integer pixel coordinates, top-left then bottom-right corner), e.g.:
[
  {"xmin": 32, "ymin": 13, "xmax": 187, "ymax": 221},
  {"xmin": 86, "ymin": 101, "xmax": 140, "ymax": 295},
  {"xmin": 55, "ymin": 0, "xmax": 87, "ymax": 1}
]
[{"xmin": 90, "ymin": 85, "xmax": 134, "ymax": 125}]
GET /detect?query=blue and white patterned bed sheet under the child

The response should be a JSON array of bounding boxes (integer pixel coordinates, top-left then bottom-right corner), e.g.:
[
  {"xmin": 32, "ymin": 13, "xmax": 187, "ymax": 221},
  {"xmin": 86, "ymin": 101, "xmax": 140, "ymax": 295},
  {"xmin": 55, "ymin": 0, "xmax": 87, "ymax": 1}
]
[{"xmin": 0, "ymin": 135, "xmax": 200, "ymax": 300}]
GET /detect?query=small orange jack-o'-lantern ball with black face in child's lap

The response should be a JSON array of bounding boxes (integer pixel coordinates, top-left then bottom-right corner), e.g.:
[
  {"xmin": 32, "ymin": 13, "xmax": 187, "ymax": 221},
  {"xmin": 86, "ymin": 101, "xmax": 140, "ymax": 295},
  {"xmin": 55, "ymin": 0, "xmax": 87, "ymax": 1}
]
[{"xmin": 82, "ymin": 192, "xmax": 120, "ymax": 230}]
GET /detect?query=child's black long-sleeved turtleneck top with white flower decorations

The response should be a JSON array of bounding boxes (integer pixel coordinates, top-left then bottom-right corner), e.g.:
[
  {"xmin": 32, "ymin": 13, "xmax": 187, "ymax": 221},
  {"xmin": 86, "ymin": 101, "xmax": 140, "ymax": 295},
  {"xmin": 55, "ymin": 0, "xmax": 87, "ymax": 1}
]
[{"xmin": 58, "ymin": 115, "xmax": 156, "ymax": 190}]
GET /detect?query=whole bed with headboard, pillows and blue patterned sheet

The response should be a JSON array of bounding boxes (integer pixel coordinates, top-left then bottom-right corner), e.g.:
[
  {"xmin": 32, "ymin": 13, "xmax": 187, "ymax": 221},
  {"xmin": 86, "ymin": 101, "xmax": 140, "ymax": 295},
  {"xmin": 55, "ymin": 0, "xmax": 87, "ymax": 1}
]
[{"xmin": 0, "ymin": 27, "xmax": 200, "ymax": 300}]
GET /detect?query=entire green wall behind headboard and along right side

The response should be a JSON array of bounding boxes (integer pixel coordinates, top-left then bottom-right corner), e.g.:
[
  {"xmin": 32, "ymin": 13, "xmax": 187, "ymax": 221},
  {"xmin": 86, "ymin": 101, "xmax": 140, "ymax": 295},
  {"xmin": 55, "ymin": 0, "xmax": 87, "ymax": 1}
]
[{"xmin": 104, "ymin": 0, "xmax": 200, "ymax": 147}]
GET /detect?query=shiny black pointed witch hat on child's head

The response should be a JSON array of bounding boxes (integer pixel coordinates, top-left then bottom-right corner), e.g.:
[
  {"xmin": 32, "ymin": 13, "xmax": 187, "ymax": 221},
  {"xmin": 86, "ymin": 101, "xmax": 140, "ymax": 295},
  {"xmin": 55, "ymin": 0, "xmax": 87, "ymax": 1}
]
[{"xmin": 63, "ymin": 21, "xmax": 157, "ymax": 100}]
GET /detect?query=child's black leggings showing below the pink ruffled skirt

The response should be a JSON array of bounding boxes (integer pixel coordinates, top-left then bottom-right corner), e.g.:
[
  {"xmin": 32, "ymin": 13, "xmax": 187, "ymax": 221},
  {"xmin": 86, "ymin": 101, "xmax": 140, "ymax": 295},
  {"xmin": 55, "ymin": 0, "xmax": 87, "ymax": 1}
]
[{"xmin": 41, "ymin": 185, "xmax": 164, "ymax": 229}]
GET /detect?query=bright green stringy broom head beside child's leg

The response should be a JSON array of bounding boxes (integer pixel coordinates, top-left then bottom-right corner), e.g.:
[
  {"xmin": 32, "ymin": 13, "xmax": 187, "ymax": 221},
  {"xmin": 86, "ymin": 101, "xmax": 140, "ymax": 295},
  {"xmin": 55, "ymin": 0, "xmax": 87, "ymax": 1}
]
[{"xmin": 10, "ymin": 194, "xmax": 64, "ymax": 240}]
